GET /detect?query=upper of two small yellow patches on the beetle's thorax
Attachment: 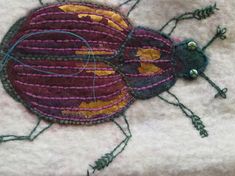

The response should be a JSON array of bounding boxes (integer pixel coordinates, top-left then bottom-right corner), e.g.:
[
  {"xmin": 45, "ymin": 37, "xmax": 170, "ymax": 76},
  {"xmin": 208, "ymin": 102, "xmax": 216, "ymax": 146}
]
[{"xmin": 136, "ymin": 48, "xmax": 161, "ymax": 60}]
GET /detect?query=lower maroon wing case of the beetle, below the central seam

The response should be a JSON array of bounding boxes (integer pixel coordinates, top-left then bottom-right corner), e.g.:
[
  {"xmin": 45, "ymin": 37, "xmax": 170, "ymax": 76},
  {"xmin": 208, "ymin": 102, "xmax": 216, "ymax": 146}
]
[{"xmin": 7, "ymin": 60, "xmax": 133, "ymax": 124}]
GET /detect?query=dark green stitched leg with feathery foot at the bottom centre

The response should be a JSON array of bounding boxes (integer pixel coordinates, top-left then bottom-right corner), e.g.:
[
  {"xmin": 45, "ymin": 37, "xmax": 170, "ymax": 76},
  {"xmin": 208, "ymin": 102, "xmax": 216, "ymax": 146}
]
[{"xmin": 87, "ymin": 115, "xmax": 132, "ymax": 176}]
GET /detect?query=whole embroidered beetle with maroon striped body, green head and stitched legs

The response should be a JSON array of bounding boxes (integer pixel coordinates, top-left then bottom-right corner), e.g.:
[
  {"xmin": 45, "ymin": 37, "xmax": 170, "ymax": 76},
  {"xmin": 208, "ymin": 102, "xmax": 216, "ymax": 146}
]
[{"xmin": 0, "ymin": 2, "xmax": 227, "ymax": 175}]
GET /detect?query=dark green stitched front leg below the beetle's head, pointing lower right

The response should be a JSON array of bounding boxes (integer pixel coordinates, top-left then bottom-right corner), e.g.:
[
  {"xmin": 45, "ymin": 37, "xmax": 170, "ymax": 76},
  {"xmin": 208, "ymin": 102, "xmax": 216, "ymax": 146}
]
[{"xmin": 158, "ymin": 91, "xmax": 208, "ymax": 138}]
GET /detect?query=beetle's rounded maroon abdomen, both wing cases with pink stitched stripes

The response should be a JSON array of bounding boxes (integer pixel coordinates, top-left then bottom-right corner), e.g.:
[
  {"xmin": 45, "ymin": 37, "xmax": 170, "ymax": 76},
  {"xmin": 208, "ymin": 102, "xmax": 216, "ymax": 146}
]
[{"xmin": 2, "ymin": 3, "xmax": 133, "ymax": 124}]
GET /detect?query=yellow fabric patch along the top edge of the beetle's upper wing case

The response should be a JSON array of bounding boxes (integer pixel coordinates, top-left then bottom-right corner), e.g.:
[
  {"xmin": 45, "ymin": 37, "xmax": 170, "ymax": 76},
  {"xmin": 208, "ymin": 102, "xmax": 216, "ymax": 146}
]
[{"xmin": 59, "ymin": 4, "xmax": 128, "ymax": 30}]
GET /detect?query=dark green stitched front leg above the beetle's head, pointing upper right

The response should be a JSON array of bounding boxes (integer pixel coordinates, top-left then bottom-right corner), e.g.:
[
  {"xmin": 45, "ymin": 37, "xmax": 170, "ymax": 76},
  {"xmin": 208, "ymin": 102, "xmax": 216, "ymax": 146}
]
[{"xmin": 160, "ymin": 3, "xmax": 219, "ymax": 36}]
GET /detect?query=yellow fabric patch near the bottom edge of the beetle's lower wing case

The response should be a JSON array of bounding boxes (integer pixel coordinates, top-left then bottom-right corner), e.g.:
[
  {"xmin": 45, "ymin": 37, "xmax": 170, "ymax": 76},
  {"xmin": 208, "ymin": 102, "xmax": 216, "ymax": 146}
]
[{"xmin": 62, "ymin": 91, "xmax": 128, "ymax": 118}]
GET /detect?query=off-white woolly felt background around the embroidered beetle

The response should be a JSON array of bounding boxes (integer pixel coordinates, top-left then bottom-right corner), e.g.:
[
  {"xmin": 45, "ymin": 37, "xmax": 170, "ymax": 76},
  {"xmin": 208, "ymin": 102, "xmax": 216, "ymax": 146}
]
[{"xmin": 0, "ymin": 0, "xmax": 235, "ymax": 176}]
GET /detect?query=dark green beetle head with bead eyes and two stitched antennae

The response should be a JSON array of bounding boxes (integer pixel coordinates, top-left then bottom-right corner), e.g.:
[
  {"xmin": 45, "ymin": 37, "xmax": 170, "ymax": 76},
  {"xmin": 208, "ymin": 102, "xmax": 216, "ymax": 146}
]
[{"xmin": 174, "ymin": 36, "xmax": 228, "ymax": 98}]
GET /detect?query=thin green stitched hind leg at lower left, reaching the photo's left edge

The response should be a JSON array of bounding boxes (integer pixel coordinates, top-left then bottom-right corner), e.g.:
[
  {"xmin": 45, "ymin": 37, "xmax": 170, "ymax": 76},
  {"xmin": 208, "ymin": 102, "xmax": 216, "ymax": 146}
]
[{"xmin": 0, "ymin": 118, "xmax": 53, "ymax": 143}]
